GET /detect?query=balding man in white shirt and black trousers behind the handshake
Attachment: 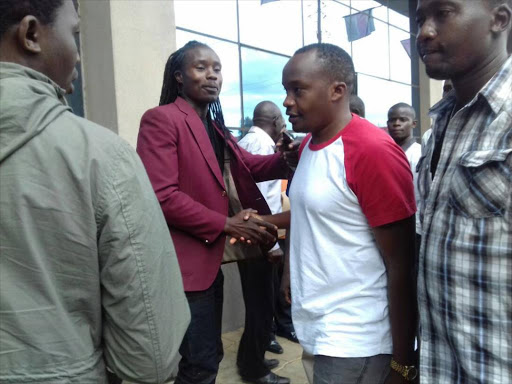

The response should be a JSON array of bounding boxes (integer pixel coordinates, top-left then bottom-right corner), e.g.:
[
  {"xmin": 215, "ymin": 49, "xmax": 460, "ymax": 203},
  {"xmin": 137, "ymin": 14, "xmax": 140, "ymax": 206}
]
[{"xmin": 237, "ymin": 101, "xmax": 291, "ymax": 383}]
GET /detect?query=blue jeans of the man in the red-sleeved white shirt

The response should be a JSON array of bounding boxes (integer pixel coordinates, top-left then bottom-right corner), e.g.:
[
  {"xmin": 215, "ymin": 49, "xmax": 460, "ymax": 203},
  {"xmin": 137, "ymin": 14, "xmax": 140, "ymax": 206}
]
[{"xmin": 313, "ymin": 355, "xmax": 391, "ymax": 384}]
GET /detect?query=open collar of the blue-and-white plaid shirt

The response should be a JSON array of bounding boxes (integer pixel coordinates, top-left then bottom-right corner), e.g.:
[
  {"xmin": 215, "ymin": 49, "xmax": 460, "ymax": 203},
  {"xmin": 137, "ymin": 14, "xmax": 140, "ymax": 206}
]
[{"xmin": 429, "ymin": 56, "xmax": 512, "ymax": 118}]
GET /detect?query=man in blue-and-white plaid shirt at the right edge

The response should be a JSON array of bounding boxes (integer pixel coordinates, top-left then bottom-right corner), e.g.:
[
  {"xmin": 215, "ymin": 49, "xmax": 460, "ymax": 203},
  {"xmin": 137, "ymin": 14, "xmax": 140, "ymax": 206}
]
[{"xmin": 417, "ymin": 0, "xmax": 512, "ymax": 384}]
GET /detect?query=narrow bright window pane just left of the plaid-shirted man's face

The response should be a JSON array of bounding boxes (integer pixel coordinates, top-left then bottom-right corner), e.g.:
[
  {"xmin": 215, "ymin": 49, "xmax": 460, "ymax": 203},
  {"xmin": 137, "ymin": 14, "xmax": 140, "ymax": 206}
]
[{"xmin": 389, "ymin": 27, "xmax": 415, "ymax": 84}]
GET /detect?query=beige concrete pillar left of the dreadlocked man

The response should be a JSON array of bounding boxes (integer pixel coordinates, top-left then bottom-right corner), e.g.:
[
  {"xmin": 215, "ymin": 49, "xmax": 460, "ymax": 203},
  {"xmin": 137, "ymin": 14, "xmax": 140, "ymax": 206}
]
[{"xmin": 79, "ymin": 0, "xmax": 176, "ymax": 146}]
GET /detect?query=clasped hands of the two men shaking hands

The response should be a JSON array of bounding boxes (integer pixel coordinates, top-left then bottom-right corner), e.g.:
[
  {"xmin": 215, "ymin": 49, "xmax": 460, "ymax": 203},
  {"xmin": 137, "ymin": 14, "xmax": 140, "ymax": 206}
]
[{"xmin": 224, "ymin": 209, "xmax": 277, "ymax": 244}]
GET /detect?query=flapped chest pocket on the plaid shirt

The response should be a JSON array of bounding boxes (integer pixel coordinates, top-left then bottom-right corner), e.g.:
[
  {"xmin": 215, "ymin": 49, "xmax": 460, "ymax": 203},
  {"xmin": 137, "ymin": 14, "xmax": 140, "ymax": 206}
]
[{"xmin": 449, "ymin": 148, "xmax": 512, "ymax": 218}]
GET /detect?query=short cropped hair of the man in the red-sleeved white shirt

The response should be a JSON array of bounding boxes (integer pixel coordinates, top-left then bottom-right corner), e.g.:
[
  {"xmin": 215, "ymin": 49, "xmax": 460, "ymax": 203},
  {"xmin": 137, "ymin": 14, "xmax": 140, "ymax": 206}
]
[{"xmin": 295, "ymin": 43, "xmax": 356, "ymax": 89}]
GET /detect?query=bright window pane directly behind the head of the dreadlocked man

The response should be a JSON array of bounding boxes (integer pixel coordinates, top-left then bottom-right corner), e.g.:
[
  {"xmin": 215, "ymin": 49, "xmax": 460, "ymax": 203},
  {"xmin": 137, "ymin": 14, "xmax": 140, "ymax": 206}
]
[{"xmin": 176, "ymin": 29, "xmax": 242, "ymax": 127}]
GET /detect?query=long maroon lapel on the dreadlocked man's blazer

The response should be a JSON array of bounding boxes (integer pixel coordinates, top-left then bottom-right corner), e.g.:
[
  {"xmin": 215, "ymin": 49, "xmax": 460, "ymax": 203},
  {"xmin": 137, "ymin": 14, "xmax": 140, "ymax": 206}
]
[{"xmin": 175, "ymin": 97, "xmax": 225, "ymax": 189}]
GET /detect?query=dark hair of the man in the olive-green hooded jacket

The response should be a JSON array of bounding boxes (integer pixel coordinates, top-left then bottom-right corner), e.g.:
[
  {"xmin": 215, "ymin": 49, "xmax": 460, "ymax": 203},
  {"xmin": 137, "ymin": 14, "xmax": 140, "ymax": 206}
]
[{"xmin": 0, "ymin": 0, "xmax": 64, "ymax": 39}]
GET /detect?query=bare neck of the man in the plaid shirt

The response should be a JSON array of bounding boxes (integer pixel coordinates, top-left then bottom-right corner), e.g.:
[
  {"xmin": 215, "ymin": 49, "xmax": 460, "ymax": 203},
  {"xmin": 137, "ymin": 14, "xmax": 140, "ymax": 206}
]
[{"xmin": 452, "ymin": 51, "xmax": 508, "ymax": 110}]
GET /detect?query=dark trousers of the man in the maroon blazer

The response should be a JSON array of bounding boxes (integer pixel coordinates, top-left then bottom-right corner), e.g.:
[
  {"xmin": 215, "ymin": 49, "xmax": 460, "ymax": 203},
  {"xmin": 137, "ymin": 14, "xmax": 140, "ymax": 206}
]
[{"xmin": 175, "ymin": 270, "xmax": 224, "ymax": 384}]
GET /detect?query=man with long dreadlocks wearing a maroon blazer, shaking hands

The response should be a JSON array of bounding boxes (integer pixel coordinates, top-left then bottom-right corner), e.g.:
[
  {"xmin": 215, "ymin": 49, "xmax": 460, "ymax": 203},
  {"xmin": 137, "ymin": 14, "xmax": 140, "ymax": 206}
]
[{"xmin": 137, "ymin": 35, "xmax": 289, "ymax": 384}]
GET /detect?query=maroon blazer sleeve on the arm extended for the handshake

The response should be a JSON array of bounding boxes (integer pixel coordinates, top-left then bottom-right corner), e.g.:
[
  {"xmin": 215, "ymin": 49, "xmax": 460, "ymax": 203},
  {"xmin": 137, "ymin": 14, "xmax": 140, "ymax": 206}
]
[{"xmin": 137, "ymin": 108, "xmax": 226, "ymax": 243}]
